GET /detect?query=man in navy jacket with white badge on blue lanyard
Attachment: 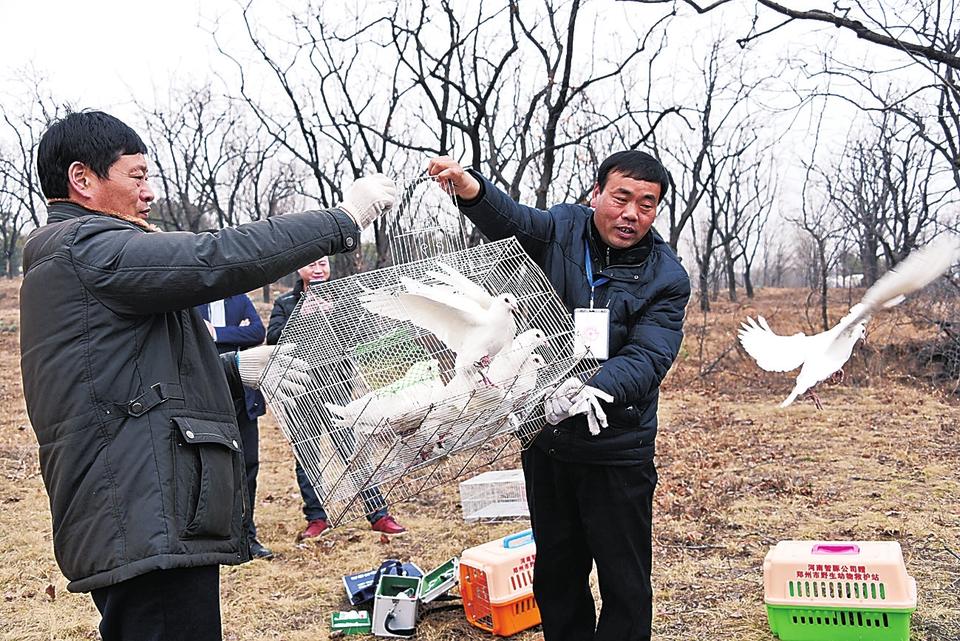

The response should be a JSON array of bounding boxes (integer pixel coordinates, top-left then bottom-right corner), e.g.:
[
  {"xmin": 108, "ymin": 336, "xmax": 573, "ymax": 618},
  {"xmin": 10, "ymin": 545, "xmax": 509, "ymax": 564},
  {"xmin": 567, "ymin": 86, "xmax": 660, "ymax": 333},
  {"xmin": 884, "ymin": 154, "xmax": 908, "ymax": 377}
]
[{"xmin": 428, "ymin": 151, "xmax": 690, "ymax": 641}]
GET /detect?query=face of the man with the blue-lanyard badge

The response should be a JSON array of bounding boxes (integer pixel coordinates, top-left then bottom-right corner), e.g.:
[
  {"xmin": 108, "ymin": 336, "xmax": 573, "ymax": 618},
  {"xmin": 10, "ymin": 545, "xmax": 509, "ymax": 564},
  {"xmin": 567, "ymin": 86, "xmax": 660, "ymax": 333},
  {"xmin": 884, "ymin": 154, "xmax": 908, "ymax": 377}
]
[{"xmin": 590, "ymin": 171, "xmax": 660, "ymax": 249}]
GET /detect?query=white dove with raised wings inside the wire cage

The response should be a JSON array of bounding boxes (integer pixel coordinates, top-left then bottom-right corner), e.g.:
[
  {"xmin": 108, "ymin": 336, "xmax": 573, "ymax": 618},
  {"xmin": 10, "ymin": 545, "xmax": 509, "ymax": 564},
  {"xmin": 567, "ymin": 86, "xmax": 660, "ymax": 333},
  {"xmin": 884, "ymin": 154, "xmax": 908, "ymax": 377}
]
[{"xmin": 360, "ymin": 263, "xmax": 519, "ymax": 376}]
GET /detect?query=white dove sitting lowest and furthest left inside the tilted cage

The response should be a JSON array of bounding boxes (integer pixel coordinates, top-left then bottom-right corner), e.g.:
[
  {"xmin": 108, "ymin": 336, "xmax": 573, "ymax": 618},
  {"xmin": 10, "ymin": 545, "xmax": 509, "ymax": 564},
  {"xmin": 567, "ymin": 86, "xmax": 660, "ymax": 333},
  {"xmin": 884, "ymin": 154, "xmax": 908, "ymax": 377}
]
[{"xmin": 324, "ymin": 359, "xmax": 443, "ymax": 434}]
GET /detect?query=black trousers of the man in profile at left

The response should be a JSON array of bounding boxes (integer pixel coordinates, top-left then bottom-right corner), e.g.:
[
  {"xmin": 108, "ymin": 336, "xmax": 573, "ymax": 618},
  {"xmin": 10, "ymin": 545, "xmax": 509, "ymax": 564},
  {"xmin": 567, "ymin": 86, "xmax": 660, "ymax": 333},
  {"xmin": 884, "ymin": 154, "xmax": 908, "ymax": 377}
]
[{"xmin": 90, "ymin": 565, "xmax": 222, "ymax": 641}]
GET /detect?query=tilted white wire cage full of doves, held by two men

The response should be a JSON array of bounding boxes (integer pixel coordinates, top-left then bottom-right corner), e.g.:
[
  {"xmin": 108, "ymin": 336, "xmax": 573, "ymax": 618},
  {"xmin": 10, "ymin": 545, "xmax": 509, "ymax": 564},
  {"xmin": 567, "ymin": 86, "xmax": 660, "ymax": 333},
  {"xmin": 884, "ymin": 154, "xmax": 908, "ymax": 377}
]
[{"xmin": 261, "ymin": 179, "xmax": 593, "ymax": 524}]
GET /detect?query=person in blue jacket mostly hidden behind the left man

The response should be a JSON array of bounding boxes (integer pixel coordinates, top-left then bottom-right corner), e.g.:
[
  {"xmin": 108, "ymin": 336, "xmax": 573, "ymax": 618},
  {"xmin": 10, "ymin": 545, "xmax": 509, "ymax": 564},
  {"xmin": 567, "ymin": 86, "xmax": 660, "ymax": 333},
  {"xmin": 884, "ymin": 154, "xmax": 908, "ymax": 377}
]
[{"xmin": 197, "ymin": 294, "xmax": 273, "ymax": 559}]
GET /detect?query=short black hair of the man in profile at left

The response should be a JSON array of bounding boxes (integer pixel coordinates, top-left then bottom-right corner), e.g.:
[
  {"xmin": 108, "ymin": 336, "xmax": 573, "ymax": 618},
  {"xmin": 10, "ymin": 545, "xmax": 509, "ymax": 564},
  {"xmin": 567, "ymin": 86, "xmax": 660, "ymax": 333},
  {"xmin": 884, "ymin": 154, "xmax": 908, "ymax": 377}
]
[{"xmin": 37, "ymin": 111, "xmax": 147, "ymax": 198}]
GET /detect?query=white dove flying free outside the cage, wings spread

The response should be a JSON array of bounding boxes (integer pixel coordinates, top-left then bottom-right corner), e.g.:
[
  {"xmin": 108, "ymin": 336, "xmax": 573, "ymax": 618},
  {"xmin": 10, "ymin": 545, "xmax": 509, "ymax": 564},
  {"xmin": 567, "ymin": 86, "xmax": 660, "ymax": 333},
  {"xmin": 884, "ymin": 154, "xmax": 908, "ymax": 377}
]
[{"xmin": 739, "ymin": 235, "xmax": 960, "ymax": 408}]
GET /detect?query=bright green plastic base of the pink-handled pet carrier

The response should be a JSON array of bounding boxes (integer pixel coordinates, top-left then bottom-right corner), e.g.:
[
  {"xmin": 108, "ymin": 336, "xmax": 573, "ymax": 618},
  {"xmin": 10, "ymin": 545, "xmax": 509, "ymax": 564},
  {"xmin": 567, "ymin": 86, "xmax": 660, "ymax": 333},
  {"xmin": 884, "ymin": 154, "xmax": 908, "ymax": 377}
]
[{"xmin": 767, "ymin": 604, "xmax": 915, "ymax": 641}]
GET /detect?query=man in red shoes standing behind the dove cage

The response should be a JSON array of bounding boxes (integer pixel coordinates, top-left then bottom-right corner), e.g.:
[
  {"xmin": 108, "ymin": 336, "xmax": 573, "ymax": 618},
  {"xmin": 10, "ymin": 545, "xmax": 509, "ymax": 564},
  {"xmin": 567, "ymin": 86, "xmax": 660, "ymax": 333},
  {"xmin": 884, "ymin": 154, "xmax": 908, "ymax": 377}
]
[{"xmin": 267, "ymin": 256, "xmax": 407, "ymax": 541}]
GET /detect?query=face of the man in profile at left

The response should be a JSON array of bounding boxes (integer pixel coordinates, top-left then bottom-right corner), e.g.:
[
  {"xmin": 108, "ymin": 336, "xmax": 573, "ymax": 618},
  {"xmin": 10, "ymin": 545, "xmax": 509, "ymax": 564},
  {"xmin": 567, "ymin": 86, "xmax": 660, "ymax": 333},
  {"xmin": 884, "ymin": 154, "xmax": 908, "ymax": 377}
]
[{"xmin": 85, "ymin": 154, "xmax": 155, "ymax": 220}]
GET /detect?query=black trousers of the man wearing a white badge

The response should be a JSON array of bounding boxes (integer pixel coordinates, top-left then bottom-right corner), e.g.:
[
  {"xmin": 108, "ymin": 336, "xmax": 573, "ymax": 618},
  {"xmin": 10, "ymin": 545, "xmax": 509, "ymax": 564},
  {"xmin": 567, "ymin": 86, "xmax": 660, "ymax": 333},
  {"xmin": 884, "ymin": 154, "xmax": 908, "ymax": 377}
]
[{"xmin": 522, "ymin": 445, "xmax": 657, "ymax": 641}]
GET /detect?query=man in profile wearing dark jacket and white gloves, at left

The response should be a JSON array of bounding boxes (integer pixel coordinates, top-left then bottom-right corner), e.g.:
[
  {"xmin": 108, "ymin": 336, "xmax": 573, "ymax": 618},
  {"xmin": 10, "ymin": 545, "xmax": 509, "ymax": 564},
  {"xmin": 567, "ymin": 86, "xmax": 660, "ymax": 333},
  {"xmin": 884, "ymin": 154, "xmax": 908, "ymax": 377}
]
[{"xmin": 20, "ymin": 112, "xmax": 396, "ymax": 641}]
